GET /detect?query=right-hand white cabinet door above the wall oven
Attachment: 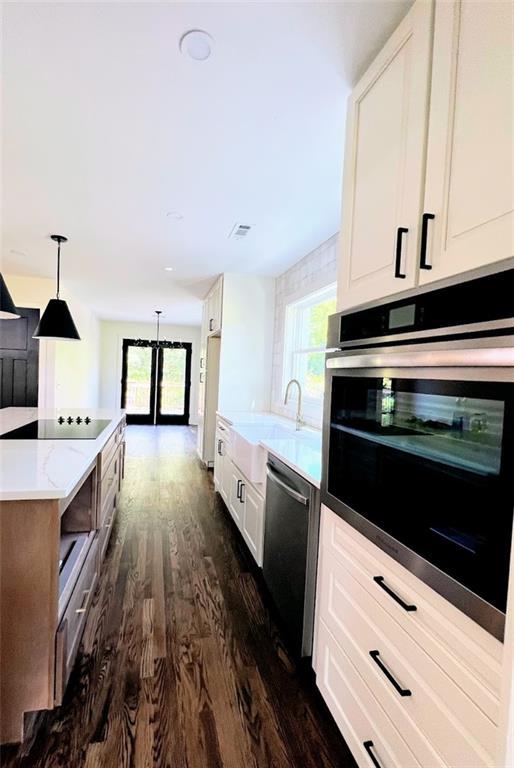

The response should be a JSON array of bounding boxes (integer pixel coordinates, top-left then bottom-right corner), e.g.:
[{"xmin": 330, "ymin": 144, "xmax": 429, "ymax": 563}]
[{"xmin": 420, "ymin": 0, "xmax": 514, "ymax": 283}]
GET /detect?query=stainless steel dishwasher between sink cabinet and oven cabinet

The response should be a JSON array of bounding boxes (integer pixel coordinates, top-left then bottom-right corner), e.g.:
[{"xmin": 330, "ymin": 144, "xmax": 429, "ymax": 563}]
[{"xmin": 262, "ymin": 456, "xmax": 320, "ymax": 657}]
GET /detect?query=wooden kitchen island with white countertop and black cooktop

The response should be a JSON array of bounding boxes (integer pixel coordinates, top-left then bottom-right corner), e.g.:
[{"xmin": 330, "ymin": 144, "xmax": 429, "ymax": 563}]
[{"xmin": 0, "ymin": 408, "xmax": 125, "ymax": 743}]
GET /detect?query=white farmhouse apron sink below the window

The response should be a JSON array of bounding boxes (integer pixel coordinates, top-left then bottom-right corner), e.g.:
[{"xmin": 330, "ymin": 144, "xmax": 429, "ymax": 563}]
[{"xmin": 229, "ymin": 422, "xmax": 312, "ymax": 483}]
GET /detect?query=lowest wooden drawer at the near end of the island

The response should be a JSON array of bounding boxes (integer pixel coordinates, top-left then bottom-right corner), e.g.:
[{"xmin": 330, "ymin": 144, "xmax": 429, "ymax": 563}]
[{"xmin": 55, "ymin": 535, "xmax": 99, "ymax": 704}]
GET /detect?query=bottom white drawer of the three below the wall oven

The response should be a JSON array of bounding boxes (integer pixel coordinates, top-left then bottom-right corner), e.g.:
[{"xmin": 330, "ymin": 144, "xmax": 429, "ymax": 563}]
[{"xmin": 316, "ymin": 621, "xmax": 418, "ymax": 768}]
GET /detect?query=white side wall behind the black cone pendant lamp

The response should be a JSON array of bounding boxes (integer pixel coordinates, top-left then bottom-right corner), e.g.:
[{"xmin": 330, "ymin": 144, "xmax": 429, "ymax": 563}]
[{"xmin": 4, "ymin": 275, "xmax": 100, "ymax": 408}]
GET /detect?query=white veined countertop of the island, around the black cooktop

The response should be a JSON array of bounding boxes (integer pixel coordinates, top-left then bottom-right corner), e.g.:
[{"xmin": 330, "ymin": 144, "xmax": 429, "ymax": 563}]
[{"xmin": 0, "ymin": 408, "xmax": 124, "ymax": 501}]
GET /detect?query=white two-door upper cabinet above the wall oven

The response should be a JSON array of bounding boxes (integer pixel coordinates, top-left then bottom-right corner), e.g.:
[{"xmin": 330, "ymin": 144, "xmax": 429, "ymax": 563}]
[{"xmin": 338, "ymin": 0, "xmax": 514, "ymax": 309}]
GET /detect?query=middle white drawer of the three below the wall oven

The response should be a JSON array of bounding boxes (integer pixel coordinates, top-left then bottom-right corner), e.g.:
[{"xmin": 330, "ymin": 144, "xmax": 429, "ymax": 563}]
[{"xmin": 319, "ymin": 548, "xmax": 497, "ymax": 768}]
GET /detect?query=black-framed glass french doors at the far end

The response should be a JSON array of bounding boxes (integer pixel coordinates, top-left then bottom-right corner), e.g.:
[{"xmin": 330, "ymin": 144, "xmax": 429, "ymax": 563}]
[{"xmin": 121, "ymin": 339, "xmax": 192, "ymax": 424}]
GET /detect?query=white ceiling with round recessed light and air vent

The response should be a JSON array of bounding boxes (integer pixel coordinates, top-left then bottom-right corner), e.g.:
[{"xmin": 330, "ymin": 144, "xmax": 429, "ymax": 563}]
[{"xmin": 2, "ymin": 0, "xmax": 411, "ymax": 323}]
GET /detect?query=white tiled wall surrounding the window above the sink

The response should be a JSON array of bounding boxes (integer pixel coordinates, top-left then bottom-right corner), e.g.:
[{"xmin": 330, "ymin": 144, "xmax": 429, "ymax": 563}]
[{"xmin": 271, "ymin": 234, "xmax": 338, "ymax": 427}]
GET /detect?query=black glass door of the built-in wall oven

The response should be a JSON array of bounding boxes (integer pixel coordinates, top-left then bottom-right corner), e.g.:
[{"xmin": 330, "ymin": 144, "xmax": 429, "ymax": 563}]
[{"xmin": 326, "ymin": 376, "xmax": 514, "ymax": 612}]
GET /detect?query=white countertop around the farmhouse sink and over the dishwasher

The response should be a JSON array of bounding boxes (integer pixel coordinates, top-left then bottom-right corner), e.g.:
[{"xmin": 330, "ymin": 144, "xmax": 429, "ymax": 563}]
[{"xmin": 218, "ymin": 411, "xmax": 321, "ymax": 488}]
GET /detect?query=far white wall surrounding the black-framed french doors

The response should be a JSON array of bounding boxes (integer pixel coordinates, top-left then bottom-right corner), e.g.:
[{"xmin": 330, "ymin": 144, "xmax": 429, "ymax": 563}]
[{"xmin": 100, "ymin": 320, "xmax": 200, "ymax": 424}]
